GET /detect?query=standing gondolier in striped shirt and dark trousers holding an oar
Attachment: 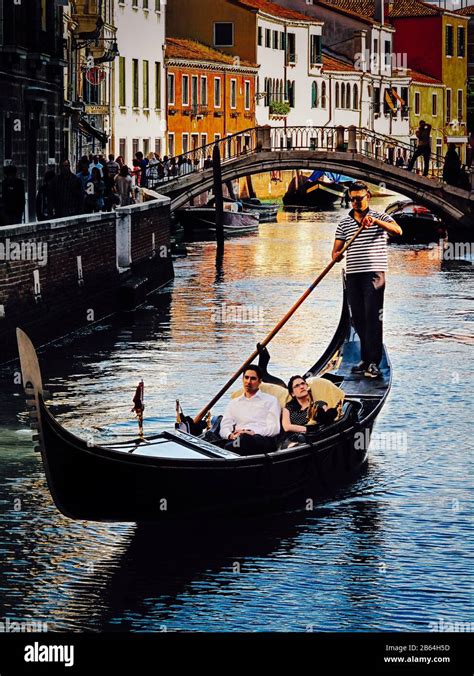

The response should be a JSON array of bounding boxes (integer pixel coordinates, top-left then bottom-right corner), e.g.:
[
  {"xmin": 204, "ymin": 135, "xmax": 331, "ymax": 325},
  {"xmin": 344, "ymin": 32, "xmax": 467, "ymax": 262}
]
[{"xmin": 332, "ymin": 181, "xmax": 402, "ymax": 378}]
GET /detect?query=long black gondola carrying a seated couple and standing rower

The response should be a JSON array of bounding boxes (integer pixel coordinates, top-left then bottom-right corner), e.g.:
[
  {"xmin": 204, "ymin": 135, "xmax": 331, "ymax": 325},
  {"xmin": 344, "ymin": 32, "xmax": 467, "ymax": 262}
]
[{"xmin": 18, "ymin": 288, "xmax": 391, "ymax": 522}]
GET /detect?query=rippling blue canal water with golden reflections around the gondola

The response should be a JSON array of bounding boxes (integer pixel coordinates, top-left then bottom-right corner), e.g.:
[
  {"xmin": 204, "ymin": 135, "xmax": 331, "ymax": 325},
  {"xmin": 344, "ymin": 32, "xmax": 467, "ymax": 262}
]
[{"xmin": 0, "ymin": 199, "xmax": 474, "ymax": 632}]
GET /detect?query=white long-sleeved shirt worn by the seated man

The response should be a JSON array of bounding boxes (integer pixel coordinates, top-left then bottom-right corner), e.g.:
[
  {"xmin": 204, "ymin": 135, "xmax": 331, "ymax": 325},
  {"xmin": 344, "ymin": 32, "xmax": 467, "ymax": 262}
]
[{"xmin": 220, "ymin": 390, "xmax": 281, "ymax": 439}]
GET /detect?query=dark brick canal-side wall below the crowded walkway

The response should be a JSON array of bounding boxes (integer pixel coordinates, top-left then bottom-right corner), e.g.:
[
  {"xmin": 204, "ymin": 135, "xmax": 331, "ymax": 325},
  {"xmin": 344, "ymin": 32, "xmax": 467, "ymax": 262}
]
[{"xmin": 0, "ymin": 197, "xmax": 173, "ymax": 361}]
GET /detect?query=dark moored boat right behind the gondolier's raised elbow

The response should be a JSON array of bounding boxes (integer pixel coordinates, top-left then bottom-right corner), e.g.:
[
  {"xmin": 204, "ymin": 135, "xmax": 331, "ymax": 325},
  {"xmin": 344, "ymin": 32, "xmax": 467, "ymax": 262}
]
[{"xmin": 385, "ymin": 200, "xmax": 446, "ymax": 244}]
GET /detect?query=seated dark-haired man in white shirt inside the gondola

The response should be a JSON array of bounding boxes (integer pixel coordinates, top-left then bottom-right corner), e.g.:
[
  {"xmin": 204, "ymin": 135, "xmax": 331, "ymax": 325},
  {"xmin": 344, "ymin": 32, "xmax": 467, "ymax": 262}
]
[{"xmin": 220, "ymin": 364, "xmax": 281, "ymax": 455}]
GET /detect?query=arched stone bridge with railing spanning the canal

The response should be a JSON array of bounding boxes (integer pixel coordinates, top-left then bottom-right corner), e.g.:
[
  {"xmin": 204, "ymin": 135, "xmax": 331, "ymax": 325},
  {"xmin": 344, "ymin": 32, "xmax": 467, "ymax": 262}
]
[{"xmin": 153, "ymin": 127, "xmax": 474, "ymax": 230}]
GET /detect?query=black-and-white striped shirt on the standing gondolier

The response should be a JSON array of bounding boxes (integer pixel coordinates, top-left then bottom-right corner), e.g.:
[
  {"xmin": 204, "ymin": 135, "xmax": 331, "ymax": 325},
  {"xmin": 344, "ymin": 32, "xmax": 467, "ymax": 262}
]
[{"xmin": 336, "ymin": 209, "xmax": 395, "ymax": 275}]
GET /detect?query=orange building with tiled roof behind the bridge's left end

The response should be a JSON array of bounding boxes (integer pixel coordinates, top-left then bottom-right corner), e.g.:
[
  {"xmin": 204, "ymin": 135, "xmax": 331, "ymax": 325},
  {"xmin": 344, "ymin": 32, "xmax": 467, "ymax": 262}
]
[{"xmin": 165, "ymin": 38, "xmax": 258, "ymax": 157}]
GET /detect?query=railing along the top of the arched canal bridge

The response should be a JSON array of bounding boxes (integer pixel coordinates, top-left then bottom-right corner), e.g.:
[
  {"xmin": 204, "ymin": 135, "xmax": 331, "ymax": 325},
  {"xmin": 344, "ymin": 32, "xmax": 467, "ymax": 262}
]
[{"xmin": 148, "ymin": 126, "xmax": 443, "ymax": 188}]
